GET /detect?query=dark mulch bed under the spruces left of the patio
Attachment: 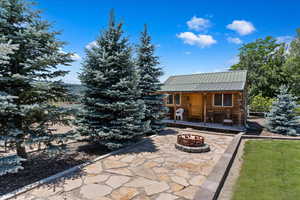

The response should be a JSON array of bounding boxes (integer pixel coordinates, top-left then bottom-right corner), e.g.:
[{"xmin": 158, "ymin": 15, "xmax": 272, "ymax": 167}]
[{"xmin": 0, "ymin": 142, "xmax": 109, "ymax": 195}]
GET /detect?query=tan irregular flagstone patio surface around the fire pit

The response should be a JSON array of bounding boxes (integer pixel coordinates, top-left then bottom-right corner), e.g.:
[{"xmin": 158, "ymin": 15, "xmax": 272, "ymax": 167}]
[{"xmin": 17, "ymin": 130, "xmax": 233, "ymax": 200}]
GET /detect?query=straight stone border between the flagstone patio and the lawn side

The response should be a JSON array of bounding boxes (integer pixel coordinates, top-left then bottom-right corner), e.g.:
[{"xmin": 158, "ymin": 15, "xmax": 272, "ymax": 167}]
[{"xmin": 194, "ymin": 132, "xmax": 244, "ymax": 200}]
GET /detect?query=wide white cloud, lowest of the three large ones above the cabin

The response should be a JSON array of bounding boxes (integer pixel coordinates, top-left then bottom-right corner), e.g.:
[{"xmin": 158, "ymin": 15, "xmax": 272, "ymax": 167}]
[{"xmin": 177, "ymin": 32, "xmax": 217, "ymax": 48}]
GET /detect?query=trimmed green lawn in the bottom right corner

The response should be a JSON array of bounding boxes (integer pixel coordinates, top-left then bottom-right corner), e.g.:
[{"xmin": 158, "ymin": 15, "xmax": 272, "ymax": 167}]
[{"xmin": 233, "ymin": 140, "xmax": 300, "ymax": 200}]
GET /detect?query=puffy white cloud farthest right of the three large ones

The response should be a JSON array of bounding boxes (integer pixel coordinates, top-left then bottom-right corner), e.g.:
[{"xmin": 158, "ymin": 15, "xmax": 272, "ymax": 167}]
[{"xmin": 226, "ymin": 20, "xmax": 255, "ymax": 35}]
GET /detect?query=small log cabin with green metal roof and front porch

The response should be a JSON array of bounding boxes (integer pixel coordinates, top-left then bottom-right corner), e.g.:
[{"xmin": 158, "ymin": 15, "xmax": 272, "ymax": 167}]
[{"xmin": 160, "ymin": 70, "xmax": 247, "ymax": 131}]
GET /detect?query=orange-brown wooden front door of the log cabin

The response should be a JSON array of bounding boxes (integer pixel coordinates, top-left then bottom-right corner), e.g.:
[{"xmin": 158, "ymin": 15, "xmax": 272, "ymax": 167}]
[{"xmin": 189, "ymin": 93, "xmax": 203, "ymax": 121}]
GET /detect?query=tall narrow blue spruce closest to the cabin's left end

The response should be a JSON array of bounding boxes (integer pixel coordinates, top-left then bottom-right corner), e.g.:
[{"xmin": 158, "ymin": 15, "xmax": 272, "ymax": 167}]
[{"xmin": 136, "ymin": 25, "xmax": 166, "ymax": 134}]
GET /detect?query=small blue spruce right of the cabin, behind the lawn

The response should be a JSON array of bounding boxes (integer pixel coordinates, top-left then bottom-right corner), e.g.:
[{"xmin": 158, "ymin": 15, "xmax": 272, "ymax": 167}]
[{"xmin": 267, "ymin": 86, "xmax": 300, "ymax": 136}]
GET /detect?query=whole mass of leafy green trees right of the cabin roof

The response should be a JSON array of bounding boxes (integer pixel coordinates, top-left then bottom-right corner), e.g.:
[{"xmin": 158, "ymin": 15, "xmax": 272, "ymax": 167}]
[{"xmin": 231, "ymin": 29, "xmax": 300, "ymax": 99}]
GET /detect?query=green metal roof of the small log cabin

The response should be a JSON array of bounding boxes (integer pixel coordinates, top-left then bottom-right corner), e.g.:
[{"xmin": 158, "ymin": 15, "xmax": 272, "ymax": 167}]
[{"xmin": 161, "ymin": 70, "xmax": 247, "ymax": 92}]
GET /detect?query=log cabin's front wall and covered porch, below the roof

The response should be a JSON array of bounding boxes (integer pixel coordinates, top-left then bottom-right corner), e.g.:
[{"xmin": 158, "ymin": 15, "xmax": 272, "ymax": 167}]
[{"xmin": 164, "ymin": 91, "xmax": 246, "ymax": 131}]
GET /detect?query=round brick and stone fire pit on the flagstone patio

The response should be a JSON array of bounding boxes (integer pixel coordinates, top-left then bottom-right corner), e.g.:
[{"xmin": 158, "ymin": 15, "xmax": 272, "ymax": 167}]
[{"xmin": 175, "ymin": 133, "xmax": 210, "ymax": 153}]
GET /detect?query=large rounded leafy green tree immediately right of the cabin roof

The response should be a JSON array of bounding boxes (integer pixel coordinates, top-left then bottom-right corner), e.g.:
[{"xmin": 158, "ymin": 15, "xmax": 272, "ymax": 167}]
[{"xmin": 231, "ymin": 36, "xmax": 289, "ymax": 101}]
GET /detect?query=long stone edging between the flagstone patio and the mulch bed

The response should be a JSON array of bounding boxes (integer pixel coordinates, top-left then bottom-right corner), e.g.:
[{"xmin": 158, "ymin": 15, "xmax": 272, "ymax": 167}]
[{"xmin": 0, "ymin": 134, "xmax": 159, "ymax": 200}]
